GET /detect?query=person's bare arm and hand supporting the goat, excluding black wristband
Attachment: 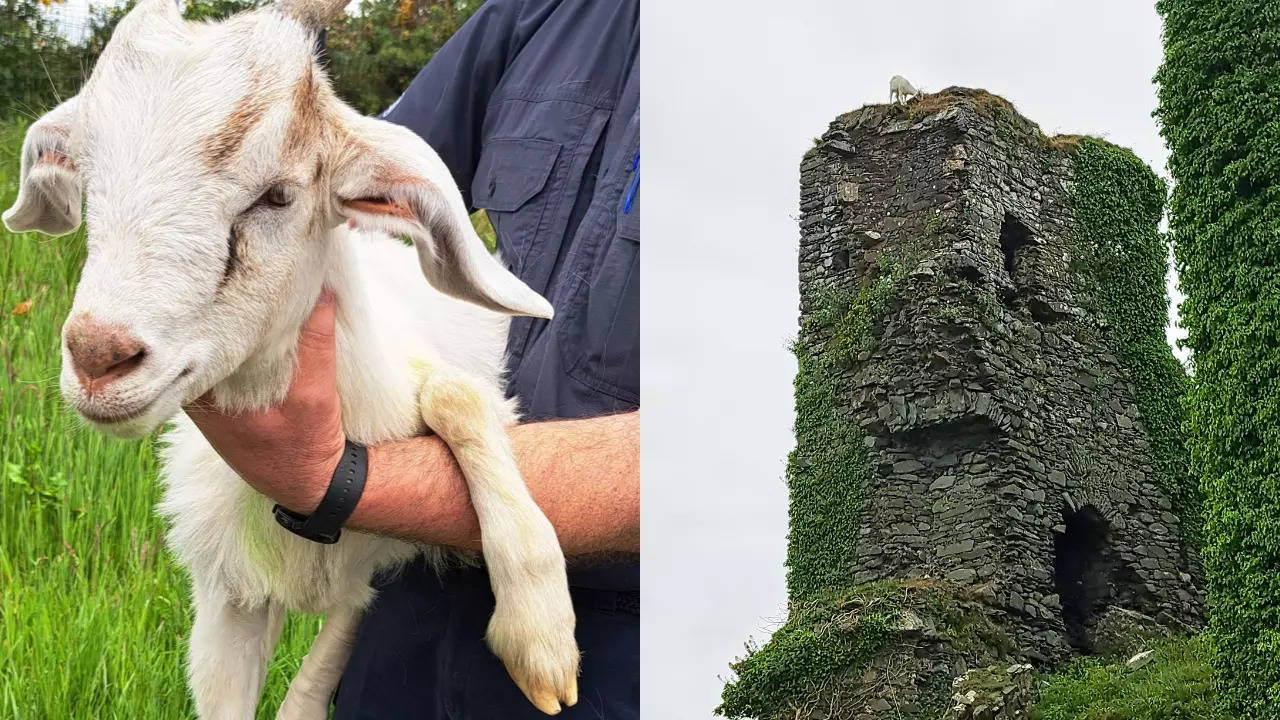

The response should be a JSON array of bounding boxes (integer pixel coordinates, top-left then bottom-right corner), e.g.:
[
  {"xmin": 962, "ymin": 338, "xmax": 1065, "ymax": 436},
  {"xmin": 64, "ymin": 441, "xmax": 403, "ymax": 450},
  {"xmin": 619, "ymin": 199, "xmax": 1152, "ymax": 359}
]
[{"xmin": 187, "ymin": 293, "xmax": 640, "ymax": 556}]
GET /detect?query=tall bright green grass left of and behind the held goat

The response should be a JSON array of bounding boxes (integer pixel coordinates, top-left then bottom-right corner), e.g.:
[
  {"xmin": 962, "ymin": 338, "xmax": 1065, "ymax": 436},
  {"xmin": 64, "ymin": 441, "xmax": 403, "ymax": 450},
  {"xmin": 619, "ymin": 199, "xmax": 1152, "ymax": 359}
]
[{"xmin": 0, "ymin": 122, "xmax": 317, "ymax": 720}]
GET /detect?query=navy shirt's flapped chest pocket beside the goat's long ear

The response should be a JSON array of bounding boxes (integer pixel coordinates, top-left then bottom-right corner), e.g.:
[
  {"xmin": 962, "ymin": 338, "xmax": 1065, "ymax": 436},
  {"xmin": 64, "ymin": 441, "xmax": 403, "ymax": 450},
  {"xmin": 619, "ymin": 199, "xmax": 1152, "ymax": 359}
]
[{"xmin": 471, "ymin": 138, "xmax": 561, "ymax": 272}]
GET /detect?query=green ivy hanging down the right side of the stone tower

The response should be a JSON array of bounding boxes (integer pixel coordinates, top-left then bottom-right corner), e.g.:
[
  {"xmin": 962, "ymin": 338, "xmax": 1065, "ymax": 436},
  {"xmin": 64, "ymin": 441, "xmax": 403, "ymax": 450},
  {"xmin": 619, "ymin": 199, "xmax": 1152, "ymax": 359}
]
[{"xmin": 1073, "ymin": 137, "xmax": 1204, "ymax": 548}]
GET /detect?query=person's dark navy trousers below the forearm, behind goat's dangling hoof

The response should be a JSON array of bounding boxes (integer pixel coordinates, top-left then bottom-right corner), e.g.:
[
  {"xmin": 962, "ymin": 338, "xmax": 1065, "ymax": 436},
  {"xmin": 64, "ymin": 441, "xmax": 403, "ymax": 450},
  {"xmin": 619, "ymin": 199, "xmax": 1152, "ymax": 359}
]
[{"xmin": 334, "ymin": 564, "xmax": 640, "ymax": 720}]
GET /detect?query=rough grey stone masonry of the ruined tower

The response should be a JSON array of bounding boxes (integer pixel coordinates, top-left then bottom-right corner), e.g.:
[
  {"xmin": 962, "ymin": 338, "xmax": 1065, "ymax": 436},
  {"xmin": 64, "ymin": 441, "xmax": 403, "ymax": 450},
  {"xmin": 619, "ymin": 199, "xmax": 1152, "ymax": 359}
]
[{"xmin": 792, "ymin": 88, "xmax": 1203, "ymax": 707}]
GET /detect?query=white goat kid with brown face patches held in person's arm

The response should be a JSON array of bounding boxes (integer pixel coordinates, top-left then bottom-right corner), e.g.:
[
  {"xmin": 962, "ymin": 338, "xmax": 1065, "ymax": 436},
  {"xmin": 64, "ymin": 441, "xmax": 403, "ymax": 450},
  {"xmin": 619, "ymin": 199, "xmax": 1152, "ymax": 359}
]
[{"xmin": 4, "ymin": 0, "xmax": 579, "ymax": 720}]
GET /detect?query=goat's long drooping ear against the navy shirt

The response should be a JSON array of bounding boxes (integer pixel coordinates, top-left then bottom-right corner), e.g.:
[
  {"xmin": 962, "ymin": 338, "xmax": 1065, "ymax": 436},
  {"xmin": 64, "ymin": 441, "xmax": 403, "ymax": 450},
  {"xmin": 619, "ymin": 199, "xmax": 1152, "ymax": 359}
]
[{"xmin": 333, "ymin": 117, "xmax": 552, "ymax": 318}]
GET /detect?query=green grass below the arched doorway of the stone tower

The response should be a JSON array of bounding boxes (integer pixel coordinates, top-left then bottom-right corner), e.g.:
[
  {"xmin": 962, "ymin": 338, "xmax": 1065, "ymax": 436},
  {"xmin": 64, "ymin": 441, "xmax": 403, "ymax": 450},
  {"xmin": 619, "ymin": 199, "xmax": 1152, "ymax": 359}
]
[{"xmin": 1032, "ymin": 635, "xmax": 1234, "ymax": 720}]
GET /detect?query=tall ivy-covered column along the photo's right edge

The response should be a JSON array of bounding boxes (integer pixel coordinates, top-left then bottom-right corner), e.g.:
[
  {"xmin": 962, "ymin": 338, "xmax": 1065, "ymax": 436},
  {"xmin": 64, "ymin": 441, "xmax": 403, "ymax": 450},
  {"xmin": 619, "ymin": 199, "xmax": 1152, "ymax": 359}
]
[{"xmin": 1157, "ymin": 0, "xmax": 1280, "ymax": 720}]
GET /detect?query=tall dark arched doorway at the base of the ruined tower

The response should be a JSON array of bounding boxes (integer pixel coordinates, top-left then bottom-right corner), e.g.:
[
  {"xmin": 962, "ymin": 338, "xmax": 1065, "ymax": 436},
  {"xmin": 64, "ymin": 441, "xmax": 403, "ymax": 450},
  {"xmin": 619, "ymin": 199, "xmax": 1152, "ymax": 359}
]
[{"xmin": 1053, "ymin": 505, "xmax": 1111, "ymax": 652}]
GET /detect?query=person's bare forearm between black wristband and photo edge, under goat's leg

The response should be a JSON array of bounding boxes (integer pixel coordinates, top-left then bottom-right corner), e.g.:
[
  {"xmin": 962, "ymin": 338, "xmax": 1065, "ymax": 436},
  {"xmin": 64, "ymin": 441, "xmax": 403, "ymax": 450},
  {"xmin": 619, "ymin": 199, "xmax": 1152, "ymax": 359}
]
[{"xmin": 347, "ymin": 413, "xmax": 640, "ymax": 556}]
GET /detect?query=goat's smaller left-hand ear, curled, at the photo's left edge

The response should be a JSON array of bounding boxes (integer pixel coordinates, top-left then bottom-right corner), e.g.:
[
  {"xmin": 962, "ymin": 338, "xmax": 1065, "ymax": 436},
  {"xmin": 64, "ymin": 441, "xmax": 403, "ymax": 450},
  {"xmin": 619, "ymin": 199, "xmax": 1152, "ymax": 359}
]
[{"xmin": 0, "ymin": 97, "xmax": 81, "ymax": 236}]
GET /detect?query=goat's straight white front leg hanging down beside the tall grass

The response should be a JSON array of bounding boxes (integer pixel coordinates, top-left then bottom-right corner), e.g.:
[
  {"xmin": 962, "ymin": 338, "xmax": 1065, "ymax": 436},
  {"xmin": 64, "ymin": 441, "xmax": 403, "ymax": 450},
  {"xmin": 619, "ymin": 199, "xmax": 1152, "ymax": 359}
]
[{"xmin": 187, "ymin": 571, "xmax": 284, "ymax": 720}]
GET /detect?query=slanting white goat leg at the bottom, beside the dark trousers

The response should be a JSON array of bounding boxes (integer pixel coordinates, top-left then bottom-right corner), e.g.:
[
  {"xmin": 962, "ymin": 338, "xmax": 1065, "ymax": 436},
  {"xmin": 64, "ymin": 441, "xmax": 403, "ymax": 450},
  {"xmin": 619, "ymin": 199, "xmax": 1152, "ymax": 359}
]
[{"xmin": 275, "ymin": 609, "xmax": 361, "ymax": 720}]
